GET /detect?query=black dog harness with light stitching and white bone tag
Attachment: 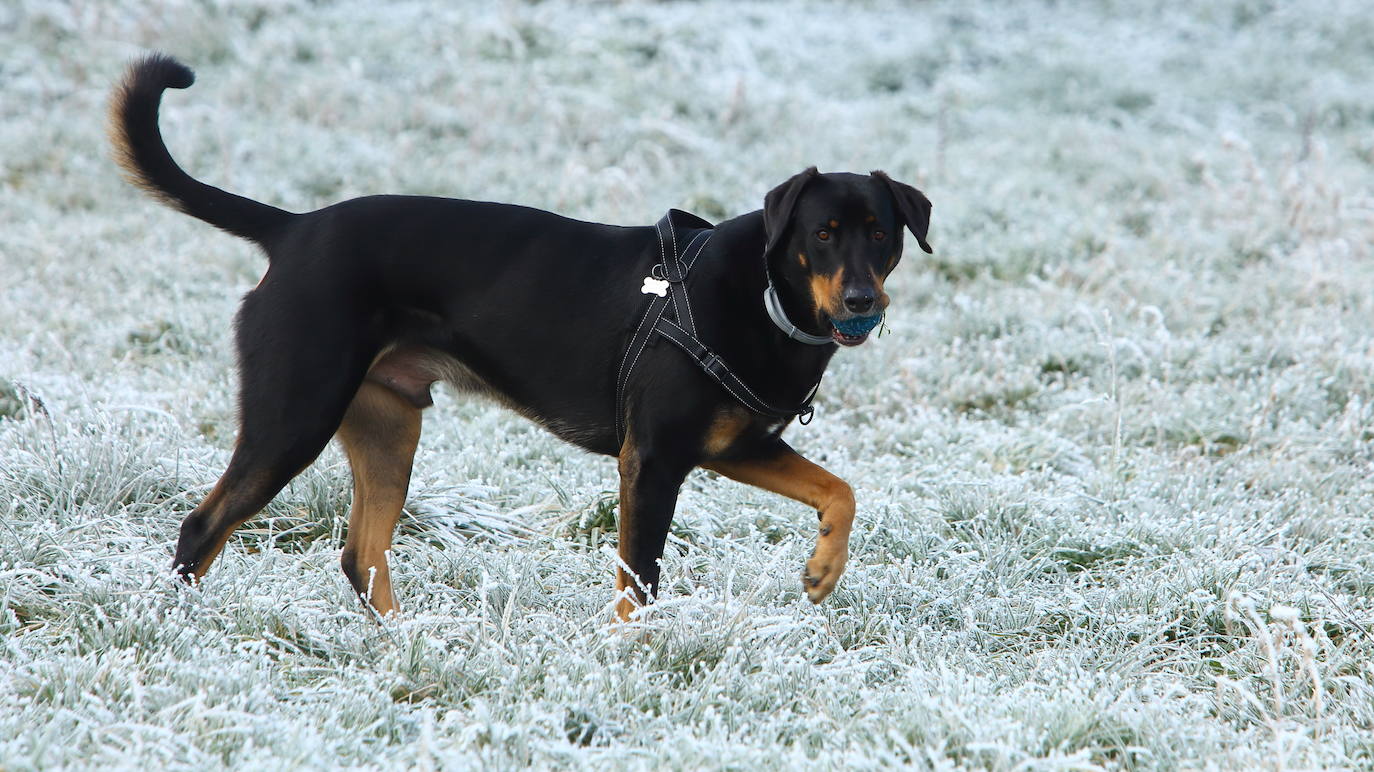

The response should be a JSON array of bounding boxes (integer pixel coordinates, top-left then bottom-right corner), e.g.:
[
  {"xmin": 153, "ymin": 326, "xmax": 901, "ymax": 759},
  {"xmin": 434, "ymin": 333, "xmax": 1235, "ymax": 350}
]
[{"xmin": 616, "ymin": 209, "xmax": 820, "ymax": 441}]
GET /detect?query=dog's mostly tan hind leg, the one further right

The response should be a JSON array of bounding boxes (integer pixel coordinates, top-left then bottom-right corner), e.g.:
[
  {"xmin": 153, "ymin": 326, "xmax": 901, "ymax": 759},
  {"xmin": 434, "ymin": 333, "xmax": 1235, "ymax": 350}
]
[{"xmin": 338, "ymin": 381, "xmax": 420, "ymax": 615}]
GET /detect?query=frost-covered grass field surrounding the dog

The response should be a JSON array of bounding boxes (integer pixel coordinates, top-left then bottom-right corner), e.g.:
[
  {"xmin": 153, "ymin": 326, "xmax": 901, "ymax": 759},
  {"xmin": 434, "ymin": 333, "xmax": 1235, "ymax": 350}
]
[{"xmin": 0, "ymin": 0, "xmax": 1374, "ymax": 771}]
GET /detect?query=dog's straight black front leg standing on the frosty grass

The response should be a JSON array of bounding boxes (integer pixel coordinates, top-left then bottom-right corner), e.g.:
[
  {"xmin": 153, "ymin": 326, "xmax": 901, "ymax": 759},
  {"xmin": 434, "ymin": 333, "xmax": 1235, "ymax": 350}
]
[{"xmin": 616, "ymin": 437, "xmax": 692, "ymax": 621}]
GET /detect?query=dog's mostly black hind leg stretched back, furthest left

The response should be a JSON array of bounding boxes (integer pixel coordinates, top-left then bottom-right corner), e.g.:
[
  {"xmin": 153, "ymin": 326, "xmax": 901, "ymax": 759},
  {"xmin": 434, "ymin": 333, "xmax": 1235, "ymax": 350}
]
[{"xmin": 173, "ymin": 287, "xmax": 375, "ymax": 581}]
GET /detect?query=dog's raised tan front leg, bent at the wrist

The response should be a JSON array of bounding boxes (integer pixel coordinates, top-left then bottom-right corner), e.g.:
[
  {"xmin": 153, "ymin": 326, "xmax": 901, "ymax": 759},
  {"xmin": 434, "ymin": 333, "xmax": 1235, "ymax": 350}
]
[{"xmin": 703, "ymin": 440, "xmax": 855, "ymax": 603}]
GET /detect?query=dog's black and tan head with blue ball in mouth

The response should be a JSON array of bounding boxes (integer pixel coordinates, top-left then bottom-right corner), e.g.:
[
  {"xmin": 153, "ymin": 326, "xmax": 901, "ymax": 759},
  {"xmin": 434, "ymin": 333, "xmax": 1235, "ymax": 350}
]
[{"xmin": 764, "ymin": 166, "xmax": 932, "ymax": 346}]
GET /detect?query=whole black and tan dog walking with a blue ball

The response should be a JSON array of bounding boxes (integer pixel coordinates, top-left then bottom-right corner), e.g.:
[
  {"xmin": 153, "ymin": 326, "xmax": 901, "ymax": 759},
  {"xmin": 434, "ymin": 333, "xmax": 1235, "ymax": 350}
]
[{"xmin": 110, "ymin": 55, "xmax": 930, "ymax": 618}]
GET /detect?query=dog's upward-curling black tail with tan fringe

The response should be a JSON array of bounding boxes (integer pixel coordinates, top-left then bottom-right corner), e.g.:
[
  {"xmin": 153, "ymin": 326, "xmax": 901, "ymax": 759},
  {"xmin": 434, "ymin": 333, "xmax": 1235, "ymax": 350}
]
[{"xmin": 109, "ymin": 54, "xmax": 294, "ymax": 245}]
